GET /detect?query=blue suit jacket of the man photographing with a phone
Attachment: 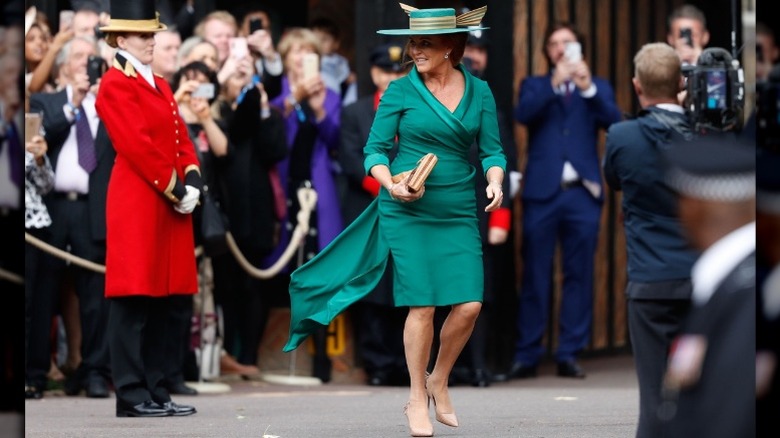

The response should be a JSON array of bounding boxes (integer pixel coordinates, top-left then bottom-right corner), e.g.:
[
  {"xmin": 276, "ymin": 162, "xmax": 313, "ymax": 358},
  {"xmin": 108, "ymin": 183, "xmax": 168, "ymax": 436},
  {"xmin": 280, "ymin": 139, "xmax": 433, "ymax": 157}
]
[{"xmin": 515, "ymin": 74, "xmax": 621, "ymax": 201}]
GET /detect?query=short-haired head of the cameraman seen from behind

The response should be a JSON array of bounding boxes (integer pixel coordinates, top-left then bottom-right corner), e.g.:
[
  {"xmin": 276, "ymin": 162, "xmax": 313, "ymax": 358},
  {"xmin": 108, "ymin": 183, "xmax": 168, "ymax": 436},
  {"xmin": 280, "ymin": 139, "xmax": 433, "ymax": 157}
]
[{"xmin": 634, "ymin": 43, "xmax": 682, "ymax": 99}]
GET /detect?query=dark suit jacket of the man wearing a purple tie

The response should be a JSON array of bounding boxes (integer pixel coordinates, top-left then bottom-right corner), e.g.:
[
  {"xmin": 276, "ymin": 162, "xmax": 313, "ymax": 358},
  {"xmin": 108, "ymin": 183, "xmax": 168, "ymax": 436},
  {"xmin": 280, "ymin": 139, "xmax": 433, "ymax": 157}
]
[{"xmin": 30, "ymin": 90, "xmax": 116, "ymax": 240}]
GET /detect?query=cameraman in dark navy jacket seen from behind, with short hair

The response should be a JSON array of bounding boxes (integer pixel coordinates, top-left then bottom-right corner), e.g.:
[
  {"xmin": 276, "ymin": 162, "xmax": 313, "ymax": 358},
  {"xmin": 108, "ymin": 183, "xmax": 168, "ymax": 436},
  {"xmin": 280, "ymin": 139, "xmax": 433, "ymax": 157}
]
[{"xmin": 604, "ymin": 43, "xmax": 697, "ymax": 438}]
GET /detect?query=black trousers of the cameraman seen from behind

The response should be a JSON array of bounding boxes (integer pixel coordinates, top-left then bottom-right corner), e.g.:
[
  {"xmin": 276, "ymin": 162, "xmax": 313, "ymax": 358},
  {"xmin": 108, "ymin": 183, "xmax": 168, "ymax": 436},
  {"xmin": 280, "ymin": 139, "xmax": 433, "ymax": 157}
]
[{"xmin": 628, "ymin": 299, "xmax": 690, "ymax": 438}]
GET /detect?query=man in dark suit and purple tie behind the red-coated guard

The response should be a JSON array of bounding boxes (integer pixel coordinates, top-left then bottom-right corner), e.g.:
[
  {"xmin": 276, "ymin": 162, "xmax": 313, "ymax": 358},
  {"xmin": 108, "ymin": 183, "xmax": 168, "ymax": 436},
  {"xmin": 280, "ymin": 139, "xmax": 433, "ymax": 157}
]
[{"xmin": 27, "ymin": 37, "xmax": 115, "ymax": 397}]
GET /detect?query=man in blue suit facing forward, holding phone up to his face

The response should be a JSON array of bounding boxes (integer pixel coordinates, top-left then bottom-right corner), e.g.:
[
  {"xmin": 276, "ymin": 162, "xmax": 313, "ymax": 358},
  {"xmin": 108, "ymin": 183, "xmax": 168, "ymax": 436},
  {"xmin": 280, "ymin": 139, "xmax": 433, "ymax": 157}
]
[{"xmin": 510, "ymin": 23, "xmax": 620, "ymax": 378}]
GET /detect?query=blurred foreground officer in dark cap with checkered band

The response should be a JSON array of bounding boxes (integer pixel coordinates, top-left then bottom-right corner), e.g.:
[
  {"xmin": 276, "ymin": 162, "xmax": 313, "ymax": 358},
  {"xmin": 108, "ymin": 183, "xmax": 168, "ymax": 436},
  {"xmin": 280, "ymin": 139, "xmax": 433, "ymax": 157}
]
[{"xmin": 659, "ymin": 134, "xmax": 756, "ymax": 438}]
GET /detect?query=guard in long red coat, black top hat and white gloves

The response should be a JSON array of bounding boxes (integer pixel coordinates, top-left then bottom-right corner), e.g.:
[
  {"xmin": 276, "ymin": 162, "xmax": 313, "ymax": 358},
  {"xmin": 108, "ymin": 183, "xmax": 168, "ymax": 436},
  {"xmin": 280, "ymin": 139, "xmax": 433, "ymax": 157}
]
[{"xmin": 95, "ymin": 0, "xmax": 202, "ymax": 417}]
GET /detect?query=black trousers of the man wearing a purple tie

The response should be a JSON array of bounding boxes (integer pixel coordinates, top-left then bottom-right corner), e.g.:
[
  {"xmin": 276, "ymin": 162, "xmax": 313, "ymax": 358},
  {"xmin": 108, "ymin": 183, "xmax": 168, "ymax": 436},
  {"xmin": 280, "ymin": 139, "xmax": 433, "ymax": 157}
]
[{"xmin": 27, "ymin": 199, "xmax": 110, "ymax": 384}]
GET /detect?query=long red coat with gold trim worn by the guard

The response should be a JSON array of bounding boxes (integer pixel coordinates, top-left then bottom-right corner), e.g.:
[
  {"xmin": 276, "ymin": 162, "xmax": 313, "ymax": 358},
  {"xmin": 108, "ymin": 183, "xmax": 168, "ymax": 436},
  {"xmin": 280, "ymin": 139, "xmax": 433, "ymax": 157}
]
[{"xmin": 95, "ymin": 56, "xmax": 200, "ymax": 298}]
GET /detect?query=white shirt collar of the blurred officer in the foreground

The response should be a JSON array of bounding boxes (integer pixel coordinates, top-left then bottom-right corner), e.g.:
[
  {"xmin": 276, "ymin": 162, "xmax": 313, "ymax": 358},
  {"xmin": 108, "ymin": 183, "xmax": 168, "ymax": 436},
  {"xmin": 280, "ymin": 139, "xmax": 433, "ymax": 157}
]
[{"xmin": 691, "ymin": 222, "xmax": 756, "ymax": 306}]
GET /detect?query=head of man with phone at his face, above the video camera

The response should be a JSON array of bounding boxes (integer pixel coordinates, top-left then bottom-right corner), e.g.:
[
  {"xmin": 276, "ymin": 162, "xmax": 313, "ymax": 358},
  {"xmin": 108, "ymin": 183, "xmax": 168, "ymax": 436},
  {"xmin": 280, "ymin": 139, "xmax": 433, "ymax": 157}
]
[{"xmin": 666, "ymin": 4, "xmax": 710, "ymax": 66}]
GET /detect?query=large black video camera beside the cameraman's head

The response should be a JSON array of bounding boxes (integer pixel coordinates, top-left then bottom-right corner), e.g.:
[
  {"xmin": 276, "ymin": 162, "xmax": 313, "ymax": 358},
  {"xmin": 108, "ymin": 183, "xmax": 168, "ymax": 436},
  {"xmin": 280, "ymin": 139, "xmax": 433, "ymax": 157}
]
[{"xmin": 683, "ymin": 47, "xmax": 745, "ymax": 134}]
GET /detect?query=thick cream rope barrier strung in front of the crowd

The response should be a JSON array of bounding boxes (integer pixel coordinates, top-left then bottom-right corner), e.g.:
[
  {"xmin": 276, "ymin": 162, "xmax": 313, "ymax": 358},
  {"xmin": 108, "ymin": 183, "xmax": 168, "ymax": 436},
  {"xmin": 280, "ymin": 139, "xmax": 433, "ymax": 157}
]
[{"xmin": 22, "ymin": 187, "xmax": 317, "ymax": 278}]
